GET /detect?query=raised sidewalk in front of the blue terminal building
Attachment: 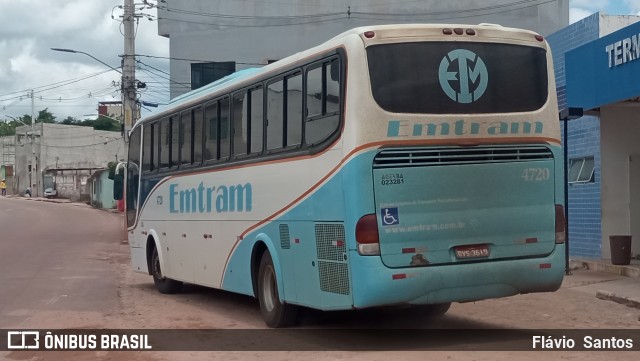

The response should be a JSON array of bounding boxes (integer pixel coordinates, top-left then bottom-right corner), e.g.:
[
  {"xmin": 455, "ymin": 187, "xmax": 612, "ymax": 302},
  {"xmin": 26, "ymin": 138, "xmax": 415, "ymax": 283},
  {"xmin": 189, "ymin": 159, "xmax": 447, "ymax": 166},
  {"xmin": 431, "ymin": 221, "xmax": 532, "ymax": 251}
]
[{"xmin": 562, "ymin": 259, "xmax": 640, "ymax": 309}]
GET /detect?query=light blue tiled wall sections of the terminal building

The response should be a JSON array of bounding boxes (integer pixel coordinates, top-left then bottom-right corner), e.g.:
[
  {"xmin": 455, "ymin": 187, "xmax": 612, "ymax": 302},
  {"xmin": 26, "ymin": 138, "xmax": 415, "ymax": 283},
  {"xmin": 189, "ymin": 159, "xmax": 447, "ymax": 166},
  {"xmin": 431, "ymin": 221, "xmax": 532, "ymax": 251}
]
[{"xmin": 547, "ymin": 13, "xmax": 602, "ymax": 258}]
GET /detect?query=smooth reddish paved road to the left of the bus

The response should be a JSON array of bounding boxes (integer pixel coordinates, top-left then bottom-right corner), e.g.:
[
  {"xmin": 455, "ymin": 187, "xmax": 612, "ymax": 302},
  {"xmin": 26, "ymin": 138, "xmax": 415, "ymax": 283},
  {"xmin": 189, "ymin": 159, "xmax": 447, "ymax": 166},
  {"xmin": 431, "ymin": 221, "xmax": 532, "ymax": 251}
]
[{"xmin": 0, "ymin": 198, "xmax": 125, "ymax": 328}]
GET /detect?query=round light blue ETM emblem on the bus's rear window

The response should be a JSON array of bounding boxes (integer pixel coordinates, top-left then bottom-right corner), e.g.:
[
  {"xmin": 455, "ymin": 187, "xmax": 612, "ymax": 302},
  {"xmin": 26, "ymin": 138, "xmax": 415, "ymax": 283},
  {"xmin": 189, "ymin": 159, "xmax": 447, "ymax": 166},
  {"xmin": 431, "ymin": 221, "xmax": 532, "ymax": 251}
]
[{"xmin": 438, "ymin": 49, "xmax": 489, "ymax": 104}]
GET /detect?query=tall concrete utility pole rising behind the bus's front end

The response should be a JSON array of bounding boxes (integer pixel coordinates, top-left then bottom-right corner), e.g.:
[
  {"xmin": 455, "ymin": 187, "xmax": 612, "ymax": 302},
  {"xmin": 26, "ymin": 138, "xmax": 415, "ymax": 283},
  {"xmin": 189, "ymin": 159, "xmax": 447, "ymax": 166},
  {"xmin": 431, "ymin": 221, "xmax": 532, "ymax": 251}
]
[{"xmin": 121, "ymin": 0, "xmax": 138, "ymax": 143}]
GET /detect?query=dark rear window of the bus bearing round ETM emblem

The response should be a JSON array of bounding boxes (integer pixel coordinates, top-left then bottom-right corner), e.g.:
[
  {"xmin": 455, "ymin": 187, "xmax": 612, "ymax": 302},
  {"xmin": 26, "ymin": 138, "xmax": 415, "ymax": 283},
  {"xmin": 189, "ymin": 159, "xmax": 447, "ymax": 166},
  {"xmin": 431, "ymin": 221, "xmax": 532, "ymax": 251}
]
[{"xmin": 367, "ymin": 42, "xmax": 548, "ymax": 114}]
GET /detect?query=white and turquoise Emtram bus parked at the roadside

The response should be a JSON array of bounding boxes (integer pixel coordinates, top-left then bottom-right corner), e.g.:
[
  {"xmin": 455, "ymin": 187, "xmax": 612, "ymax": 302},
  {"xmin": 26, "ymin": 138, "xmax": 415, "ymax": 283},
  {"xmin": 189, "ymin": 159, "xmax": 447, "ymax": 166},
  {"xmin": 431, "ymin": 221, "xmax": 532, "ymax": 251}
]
[{"xmin": 119, "ymin": 24, "xmax": 565, "ymax": 327}]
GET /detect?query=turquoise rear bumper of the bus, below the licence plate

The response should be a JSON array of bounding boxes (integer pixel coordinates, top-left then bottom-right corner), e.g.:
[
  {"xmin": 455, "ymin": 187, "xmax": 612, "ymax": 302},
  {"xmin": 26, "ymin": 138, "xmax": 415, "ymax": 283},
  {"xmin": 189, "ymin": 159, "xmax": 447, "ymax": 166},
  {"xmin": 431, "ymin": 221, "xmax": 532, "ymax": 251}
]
[{"xmin": 351, "ymin": 244, "xmax": 565, "ymax": 308}]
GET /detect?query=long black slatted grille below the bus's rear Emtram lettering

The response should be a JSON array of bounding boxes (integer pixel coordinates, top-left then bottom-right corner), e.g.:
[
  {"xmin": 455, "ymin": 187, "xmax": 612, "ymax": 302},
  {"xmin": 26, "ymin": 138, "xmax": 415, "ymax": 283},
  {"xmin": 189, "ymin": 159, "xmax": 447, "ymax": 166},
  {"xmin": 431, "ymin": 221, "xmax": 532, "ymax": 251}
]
[{"xmin": 373, "ymin": 146, "xmax": 553, "ymax": 169}]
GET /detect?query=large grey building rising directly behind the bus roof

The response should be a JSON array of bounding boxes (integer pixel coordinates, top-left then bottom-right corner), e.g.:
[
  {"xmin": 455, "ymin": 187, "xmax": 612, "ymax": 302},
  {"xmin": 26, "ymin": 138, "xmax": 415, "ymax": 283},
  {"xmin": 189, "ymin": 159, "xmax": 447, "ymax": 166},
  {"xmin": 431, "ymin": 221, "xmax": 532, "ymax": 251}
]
[{"xmin": 158, "ymin": 0, "xmax": 569, "ymax": 98}]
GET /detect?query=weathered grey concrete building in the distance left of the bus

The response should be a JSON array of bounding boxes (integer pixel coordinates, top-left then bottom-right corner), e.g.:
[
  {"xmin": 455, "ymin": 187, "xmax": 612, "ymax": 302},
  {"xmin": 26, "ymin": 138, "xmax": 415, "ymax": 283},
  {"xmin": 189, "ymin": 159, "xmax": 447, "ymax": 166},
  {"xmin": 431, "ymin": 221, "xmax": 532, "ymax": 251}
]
[{"xmin": 13, "ymin": 123, "xmax": 126, "ymax": 201}]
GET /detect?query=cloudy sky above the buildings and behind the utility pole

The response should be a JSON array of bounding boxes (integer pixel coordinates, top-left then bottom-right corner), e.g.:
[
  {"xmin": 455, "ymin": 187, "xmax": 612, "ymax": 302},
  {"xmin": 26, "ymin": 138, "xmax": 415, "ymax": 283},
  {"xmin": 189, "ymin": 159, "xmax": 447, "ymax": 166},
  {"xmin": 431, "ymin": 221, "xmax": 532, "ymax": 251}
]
[{"xmin": 0, "ymin": 0, "xmax": 640, "ymax": 121}]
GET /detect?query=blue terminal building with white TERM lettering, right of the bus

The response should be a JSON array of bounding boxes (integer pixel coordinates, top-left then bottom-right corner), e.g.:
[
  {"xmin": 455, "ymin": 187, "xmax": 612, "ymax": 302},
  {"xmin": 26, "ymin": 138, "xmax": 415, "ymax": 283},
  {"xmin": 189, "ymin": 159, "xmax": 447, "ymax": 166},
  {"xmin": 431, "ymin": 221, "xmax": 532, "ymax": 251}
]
[{"xmin": 547, "ymin": 13, "xmax": 640, "ymax": 259}]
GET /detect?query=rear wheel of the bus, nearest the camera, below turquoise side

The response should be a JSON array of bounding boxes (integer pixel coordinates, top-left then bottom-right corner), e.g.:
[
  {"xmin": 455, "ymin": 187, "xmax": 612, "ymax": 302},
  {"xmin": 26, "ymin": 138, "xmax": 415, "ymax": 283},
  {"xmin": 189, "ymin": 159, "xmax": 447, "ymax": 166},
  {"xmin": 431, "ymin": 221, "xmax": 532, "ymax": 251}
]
[{"xmin": 258, "ymin": 251, "xmax": 298, "ymax": 328}]
